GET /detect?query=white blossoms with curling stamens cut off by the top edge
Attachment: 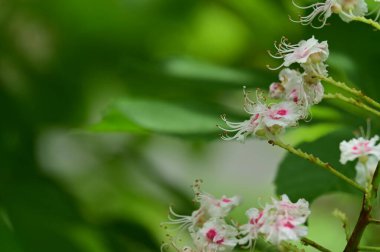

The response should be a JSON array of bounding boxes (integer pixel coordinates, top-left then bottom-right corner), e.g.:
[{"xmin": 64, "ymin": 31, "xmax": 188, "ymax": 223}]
[{"xmin": 292, "ymin": 0, "xmax": 368, "ymax": 28}]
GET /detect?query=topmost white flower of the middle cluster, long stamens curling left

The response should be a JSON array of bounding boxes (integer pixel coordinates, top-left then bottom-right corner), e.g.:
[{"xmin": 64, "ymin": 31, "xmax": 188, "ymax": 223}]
[{"xmin": 269, "ymin": 36, "xmax": 329, "ymax": 74}]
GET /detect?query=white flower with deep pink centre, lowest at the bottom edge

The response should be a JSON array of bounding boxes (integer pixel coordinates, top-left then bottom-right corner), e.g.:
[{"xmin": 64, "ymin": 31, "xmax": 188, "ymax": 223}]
[{"xmin": 191, "ymin": 219, "xmax": 238, "ymax": 252}]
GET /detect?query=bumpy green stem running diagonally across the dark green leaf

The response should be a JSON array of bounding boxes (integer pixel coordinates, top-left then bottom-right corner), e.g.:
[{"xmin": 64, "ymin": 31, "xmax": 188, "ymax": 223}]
[{"xmin": 269, "ymin": 140, "xmax": 366, "ymax": 193}]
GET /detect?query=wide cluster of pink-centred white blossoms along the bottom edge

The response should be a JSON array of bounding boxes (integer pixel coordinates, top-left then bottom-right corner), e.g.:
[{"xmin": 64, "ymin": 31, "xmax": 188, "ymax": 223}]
[{"xmin": 164, "ymin": 183, "xmax": 310, "ymax": 252}]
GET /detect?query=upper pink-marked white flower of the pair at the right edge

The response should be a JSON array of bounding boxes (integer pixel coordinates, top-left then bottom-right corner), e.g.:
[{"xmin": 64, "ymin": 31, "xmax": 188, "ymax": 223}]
[{"xmin": 339, "ymin": 135, "xmax": 380, "ymax": 164}]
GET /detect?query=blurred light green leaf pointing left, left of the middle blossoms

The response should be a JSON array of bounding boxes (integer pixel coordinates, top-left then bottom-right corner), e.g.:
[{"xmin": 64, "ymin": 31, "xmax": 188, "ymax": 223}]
[{"xmin": 90, "ymin": 98, "xmax": 218, "ymax": 135}]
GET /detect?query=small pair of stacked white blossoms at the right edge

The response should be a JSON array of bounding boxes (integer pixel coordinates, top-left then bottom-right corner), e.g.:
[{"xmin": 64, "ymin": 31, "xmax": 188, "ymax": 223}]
[{"xmin": 339, "ymin": 135, "xmax": 380, "ymax": 187}]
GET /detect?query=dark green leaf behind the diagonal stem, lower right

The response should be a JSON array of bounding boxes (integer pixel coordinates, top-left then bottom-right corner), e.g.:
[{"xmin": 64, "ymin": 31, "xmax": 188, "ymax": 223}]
[{"xmin": 275, "ymin": 130, "xmax": 356, "ymax": 202}]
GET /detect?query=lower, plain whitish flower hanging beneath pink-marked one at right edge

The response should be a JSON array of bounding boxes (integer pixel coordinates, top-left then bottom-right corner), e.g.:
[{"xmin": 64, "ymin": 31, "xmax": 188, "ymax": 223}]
[{"xmin": 355, "ymin": 156, "xmax": 379, "ymax": 187}]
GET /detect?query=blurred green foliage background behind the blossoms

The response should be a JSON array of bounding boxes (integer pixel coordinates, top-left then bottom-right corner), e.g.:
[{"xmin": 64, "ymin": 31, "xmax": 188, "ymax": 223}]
[{"xmin": 0, "ymin": 0, "xmax": 380, "ymax": 252}]
